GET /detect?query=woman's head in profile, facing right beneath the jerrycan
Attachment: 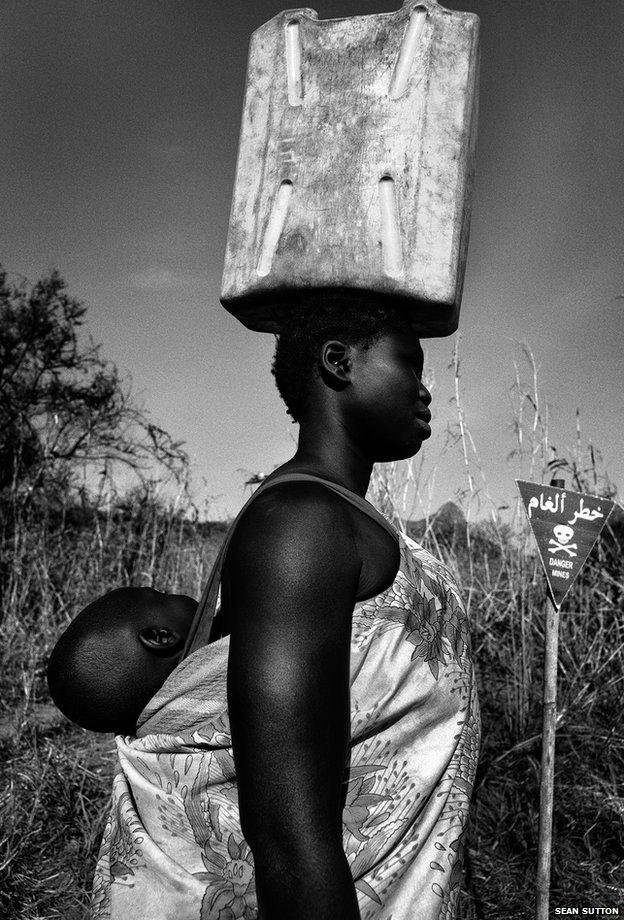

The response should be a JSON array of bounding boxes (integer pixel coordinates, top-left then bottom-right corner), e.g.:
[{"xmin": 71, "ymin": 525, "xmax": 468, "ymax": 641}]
[{"xmin": 272, "ymin": 292, "xmax": 431, "ymax": 462}]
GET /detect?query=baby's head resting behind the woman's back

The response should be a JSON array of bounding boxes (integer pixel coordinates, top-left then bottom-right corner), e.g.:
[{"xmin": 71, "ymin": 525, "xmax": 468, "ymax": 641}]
[{"xmin": 48, "ymin": 588, "xmax": 197, "ymax": 734}]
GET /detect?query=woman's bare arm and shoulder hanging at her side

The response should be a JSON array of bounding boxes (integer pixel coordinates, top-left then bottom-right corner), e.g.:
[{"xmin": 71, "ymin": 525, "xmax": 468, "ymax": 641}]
[{"xmin": 225, "ymin": 483, "xmax": 361, "ymax": 920}]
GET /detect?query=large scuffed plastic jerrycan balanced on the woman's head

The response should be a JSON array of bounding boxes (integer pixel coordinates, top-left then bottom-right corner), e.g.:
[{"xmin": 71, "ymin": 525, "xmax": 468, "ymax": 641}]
[{"xmin": 221, "ymin": 0, "xmax": 479, "ymax": 336}]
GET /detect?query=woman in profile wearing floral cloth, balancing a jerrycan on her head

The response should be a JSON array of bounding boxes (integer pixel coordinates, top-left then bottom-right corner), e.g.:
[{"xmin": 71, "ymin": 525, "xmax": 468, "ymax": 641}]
[{"xmin": 93, "ymin": 296, "xmax": 479, "ymax": 920}]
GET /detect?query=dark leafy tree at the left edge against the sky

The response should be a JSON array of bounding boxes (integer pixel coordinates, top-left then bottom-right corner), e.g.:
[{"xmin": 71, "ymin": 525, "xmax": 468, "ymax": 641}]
[{"xmin": 0, "ymin": 266, "xmax": 188, "ymax": 499}]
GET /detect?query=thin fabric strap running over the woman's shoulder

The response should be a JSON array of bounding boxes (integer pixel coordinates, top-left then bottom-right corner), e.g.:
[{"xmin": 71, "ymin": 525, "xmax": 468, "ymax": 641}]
[{"xmin": 180, "ymin": 472, "xmax": 399, "ymax": 661}]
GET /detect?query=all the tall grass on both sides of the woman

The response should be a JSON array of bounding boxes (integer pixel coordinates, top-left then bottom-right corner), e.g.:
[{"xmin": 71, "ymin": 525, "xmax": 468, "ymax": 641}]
[{"xmin": 0, "ymin": 350, "xmax": 624, "ymax": 920}]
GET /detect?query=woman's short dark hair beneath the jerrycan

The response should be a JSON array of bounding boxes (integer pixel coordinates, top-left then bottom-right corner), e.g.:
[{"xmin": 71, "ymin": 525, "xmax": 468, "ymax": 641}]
[{"xmin": 271, "ymin": 291, "xmax": 409, "ymax": 422}]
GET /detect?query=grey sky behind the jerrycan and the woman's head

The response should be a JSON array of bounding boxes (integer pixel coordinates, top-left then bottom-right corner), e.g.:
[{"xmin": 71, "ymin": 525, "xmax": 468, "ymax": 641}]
[{"xmin": 0, "ymin": 0, "xmax": 624, "ymax": 517}]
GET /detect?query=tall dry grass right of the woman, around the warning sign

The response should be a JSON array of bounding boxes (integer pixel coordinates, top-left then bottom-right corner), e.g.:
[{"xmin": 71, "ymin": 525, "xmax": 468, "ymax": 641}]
[{"xmin": 371, "ymin": 346, "xmax": 624, "ymax": 920}]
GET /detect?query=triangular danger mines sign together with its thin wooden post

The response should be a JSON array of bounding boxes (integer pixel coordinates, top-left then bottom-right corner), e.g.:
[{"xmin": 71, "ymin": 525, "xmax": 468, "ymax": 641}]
[{"xmin": 516, "ymin": 479, "xmax": 613, "ymax": 920}]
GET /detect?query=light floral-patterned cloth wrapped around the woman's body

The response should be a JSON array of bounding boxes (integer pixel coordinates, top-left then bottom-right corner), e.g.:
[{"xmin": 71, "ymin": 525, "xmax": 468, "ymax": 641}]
[{"xmin": 91, "ymin": 534, "xmax": 480, "ymax": 920}]
